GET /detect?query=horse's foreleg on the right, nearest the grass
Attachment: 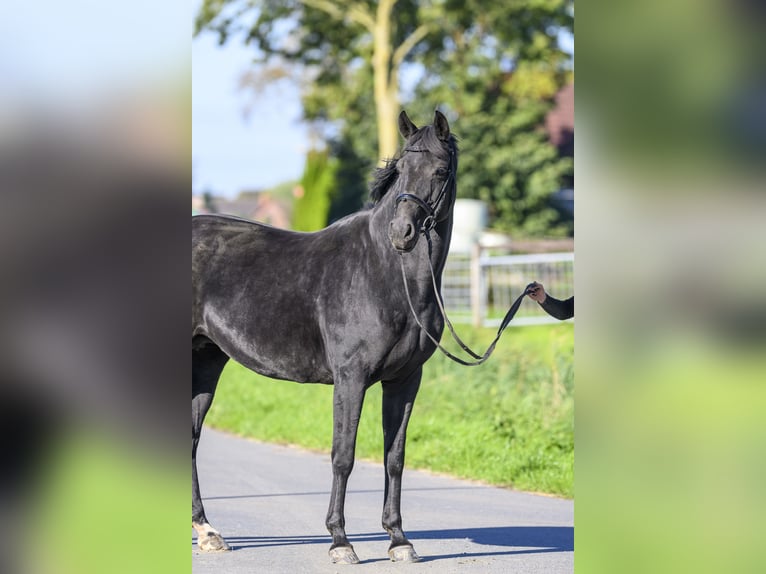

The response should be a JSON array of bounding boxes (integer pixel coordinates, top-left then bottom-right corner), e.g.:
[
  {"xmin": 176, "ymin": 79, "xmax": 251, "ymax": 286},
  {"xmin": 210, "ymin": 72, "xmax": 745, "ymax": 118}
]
[{"xmin": 382, "ymin": 368, "xmax": 422, "ymax": 562}]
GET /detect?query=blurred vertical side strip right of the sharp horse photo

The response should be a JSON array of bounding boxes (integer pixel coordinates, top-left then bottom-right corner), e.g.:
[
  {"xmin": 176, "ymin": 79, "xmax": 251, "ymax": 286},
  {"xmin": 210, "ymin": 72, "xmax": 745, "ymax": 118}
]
[{"xmin": 575, "ymin": 0, "xmax": 766, "ymax": 572}]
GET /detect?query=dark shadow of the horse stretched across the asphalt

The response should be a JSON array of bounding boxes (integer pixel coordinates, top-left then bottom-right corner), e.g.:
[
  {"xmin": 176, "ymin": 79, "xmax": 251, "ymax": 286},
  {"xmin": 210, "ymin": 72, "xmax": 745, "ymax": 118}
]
[{"xmin": 201, "ymin": 526, "xmax": 574, "ymax": 561}]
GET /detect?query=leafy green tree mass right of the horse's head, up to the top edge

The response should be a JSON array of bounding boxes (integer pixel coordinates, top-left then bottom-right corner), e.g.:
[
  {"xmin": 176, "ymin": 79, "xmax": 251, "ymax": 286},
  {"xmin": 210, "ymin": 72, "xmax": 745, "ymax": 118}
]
[{"xmin": 402, "ymin": 0, "xmax": 573, "ymax": 237}]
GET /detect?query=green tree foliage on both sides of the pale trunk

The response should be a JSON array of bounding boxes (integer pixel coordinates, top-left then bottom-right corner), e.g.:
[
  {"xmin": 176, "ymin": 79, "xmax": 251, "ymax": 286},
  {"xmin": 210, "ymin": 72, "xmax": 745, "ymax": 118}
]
[{"xmin": 196, "ymin": 0, "xmax": 574, "ymax": 237}]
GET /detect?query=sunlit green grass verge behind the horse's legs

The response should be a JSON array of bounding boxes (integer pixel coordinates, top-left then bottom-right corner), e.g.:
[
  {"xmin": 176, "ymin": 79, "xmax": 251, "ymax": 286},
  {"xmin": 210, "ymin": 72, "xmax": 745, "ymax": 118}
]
[{"xmin": 206, "ymin": 323, "xmax": 574, "ymax": 497}]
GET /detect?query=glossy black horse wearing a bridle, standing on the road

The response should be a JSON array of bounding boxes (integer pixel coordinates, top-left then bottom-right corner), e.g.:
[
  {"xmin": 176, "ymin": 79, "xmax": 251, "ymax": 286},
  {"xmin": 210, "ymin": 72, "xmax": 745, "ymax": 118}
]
[{"xmin": 192, "ymin": 111, "xmax": 457, "ymax": 564}]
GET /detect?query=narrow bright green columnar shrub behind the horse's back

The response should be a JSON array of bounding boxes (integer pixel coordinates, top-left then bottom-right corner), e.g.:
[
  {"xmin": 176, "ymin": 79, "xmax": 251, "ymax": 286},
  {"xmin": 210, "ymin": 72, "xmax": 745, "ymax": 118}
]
[{"xmin": 293, "ymin": 150, "xmax": 337, "ymax": 231}]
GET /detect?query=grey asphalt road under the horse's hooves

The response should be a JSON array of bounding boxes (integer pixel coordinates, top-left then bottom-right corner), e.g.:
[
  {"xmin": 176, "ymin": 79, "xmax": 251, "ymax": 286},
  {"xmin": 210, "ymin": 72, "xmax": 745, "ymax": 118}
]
[{"xmin": 192, "ymin": 428, "xmax": 574, "ymax": 574}]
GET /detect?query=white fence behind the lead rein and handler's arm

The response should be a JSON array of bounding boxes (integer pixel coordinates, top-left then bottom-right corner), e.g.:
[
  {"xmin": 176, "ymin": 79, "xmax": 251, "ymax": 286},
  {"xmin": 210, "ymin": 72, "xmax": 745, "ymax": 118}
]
[{"xmin": 442, "ymin": 249, "xmax": 574, "ymax": 326}]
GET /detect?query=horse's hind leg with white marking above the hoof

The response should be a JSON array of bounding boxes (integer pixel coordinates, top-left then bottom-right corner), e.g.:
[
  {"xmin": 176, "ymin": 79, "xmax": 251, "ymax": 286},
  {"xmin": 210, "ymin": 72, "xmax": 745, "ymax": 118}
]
[{"xmin": 192, "ymin": 342, "xmax": 231, "ymax": 552}]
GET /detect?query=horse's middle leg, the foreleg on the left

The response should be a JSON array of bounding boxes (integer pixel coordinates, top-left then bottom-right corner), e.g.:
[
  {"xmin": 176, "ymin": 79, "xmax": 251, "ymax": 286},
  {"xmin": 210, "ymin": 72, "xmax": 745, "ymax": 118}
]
[{"xmin": 325, "ymin": 380, "xmax": 365, "ymax": 564}]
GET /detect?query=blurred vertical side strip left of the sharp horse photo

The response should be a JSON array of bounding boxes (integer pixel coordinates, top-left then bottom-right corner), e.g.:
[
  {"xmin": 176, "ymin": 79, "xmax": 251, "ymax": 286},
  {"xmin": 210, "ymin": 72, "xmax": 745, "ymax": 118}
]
[{"xmin": 0, "ymin": 0, "xmax": 192, "ymax": 573}]
